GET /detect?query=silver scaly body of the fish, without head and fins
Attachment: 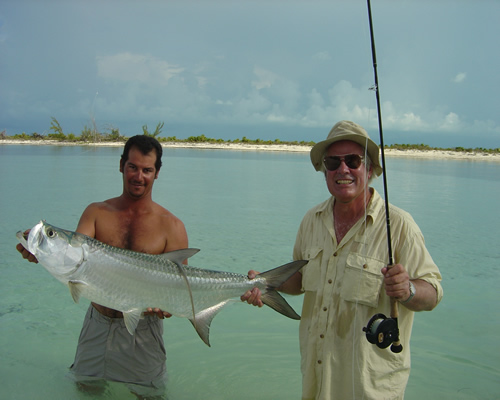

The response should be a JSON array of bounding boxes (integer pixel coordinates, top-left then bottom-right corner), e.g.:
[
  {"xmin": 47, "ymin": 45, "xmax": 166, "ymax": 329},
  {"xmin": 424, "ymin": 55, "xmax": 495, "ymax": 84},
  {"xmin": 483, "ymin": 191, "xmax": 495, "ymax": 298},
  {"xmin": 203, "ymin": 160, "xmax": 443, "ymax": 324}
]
[{"xmin": 72, "ymin": 233, "xmax": 266, "ymax": 318}]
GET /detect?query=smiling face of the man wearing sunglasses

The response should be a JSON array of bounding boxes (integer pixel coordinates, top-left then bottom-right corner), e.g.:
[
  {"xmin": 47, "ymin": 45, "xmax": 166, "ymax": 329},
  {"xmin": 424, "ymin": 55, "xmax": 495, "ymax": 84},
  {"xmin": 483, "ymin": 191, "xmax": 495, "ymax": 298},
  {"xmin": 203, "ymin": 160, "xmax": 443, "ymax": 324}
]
[{"xmin": 325, "ymin": 140, "xmax": 372, "ymax": 203}]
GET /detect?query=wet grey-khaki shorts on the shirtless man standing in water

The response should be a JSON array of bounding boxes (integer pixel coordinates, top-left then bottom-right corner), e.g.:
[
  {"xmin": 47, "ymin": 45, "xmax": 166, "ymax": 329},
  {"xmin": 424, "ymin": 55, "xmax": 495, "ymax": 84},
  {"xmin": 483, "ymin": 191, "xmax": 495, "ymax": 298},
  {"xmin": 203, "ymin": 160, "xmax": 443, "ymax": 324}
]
[{"xmin": 70, "ymin": 304, "xmax": 167, "ymax": 390}]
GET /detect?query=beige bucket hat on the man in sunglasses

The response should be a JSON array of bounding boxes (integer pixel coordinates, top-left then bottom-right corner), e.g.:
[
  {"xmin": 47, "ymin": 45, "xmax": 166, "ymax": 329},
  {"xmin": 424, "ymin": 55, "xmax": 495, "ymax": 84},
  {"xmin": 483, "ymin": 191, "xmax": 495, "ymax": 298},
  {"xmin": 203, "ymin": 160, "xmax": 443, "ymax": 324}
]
[{"xmin": 310, "ymin": 121, "xmax": 382, "ymax": 176}]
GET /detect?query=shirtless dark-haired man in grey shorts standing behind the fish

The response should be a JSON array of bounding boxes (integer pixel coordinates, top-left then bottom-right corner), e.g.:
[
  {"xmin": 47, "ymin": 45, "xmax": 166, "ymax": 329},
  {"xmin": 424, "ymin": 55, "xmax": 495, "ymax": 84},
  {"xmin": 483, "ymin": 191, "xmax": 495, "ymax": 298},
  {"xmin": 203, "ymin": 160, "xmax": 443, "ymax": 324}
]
[{"xmin": 17, "ymin": 135, "xmax": 188, "ymax": 395}]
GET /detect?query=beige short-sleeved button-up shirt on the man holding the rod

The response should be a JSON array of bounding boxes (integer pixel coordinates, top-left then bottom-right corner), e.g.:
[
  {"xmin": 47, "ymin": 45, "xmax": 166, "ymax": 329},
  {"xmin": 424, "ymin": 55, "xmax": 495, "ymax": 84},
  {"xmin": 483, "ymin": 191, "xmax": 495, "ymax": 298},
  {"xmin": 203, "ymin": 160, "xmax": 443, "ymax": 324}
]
[{"xmin": 294, "ymin": 190, "xmax": 443, "ymax": 400}]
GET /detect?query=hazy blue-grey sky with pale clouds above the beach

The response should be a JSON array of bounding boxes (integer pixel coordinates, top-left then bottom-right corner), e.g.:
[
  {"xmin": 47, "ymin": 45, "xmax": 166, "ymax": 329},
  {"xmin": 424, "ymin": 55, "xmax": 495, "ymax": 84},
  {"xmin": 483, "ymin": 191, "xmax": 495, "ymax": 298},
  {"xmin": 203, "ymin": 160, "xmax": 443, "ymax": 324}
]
[{"xmin": 0, "ymin": 0, "xmax": 500, "ymax": 148}]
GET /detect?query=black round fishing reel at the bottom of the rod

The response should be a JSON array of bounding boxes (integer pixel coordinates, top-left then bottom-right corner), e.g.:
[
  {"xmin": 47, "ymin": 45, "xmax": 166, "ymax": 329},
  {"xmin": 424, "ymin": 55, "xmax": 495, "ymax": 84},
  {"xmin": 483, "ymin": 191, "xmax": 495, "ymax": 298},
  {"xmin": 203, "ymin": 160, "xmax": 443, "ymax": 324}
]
[{"xmin": 363, "ymin": 314, "xmax": 403, "ymax": 353}]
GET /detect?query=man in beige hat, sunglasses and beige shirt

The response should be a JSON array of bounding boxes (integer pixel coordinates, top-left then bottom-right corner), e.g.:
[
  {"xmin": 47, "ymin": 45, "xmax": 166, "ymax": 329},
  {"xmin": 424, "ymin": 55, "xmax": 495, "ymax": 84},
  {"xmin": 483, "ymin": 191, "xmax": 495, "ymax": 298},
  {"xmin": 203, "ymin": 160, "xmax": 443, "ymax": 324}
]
[{"xmin": 242, "ymin": 121, "xmax": 443, "ymax": 400}]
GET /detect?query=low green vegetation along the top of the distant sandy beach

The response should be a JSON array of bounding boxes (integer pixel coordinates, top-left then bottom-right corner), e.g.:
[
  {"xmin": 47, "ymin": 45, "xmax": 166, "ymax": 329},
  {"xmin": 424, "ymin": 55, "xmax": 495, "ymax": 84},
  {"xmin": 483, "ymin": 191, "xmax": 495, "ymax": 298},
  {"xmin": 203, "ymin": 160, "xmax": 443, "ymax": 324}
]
[{"xmin": 0, "ymin": 117, "xmax": 500, "ymax": 154}]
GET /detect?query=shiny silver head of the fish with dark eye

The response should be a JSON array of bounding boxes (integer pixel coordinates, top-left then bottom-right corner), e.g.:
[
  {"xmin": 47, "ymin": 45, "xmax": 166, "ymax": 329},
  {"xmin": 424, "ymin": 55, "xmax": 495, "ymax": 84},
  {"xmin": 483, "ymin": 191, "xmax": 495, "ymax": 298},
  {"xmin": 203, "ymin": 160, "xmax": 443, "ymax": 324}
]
[{"xmin": 27, "ymin": 221, "xmax": 85, "ymax": 283}]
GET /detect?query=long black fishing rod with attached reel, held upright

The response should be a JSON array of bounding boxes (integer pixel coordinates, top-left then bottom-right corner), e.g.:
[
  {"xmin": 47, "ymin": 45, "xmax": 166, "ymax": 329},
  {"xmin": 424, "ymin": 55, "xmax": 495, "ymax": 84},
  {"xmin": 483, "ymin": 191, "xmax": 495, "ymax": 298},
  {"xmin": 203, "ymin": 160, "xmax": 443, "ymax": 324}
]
[{"xmin": 363, "ymin": 0, "xmax": 403, "ymax": 353}]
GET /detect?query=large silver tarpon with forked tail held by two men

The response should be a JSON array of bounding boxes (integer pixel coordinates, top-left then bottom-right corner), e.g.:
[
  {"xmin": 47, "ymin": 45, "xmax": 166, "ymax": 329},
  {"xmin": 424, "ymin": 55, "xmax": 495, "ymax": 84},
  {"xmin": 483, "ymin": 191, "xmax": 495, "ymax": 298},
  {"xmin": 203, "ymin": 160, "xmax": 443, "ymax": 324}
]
[{"xmin": 16, "ymin": 221, "xmax": 307, "ymax": 346}]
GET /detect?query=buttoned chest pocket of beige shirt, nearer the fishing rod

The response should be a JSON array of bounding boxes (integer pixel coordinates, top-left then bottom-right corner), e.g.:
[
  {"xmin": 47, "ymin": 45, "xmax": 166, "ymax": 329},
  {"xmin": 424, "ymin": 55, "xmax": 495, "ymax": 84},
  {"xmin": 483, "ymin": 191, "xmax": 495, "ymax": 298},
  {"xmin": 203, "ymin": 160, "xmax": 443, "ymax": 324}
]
[{"xmin": 340, "ymin": 253, "xmax": 385, "ymax": 307}]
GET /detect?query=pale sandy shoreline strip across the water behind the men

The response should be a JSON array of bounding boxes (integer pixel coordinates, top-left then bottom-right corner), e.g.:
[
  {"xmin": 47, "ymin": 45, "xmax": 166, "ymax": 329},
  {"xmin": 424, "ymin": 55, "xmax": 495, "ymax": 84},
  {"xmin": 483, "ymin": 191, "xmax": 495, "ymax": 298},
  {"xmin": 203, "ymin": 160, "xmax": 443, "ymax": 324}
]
[{"xmin": 0, "ymin": 140, "xmax": 500, "ymax": 163}]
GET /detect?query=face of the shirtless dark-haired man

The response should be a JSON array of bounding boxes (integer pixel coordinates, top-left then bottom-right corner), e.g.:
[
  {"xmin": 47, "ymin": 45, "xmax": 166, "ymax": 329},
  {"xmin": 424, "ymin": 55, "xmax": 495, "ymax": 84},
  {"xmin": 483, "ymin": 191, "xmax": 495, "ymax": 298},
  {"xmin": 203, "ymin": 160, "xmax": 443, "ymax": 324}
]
[{"xmin": 120, "ymin": 147, "xmax": 158, "ymax": 198}]
